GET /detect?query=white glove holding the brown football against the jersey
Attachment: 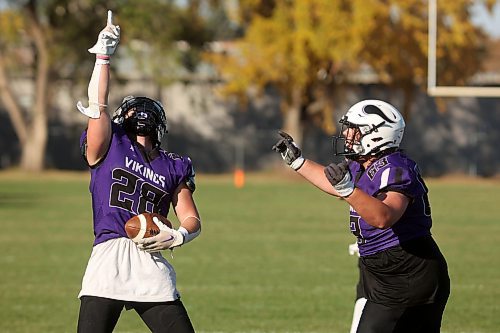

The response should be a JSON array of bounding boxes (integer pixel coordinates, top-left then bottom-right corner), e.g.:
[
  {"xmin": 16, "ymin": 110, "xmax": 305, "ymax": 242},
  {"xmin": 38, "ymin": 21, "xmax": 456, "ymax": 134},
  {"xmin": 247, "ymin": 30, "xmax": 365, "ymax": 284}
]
[{"xmin": 137, "ymin": 217, "xmax": 184, "ymax": 253}]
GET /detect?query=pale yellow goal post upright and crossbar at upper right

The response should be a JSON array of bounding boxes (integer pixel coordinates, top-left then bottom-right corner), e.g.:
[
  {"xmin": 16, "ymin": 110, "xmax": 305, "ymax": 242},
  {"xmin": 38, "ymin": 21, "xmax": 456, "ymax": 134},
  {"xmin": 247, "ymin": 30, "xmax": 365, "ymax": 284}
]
[{"xmin": 427, "ymin": 0, "xmax": 500, "ymax": 97}]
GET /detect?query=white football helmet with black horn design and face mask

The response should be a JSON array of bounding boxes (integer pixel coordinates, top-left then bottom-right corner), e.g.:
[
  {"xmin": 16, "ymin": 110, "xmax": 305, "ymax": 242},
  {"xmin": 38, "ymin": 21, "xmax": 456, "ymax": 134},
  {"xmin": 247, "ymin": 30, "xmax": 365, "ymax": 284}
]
[{"xmin": 333, "ymin": 99, "xmax": 405, "ymax": 159}]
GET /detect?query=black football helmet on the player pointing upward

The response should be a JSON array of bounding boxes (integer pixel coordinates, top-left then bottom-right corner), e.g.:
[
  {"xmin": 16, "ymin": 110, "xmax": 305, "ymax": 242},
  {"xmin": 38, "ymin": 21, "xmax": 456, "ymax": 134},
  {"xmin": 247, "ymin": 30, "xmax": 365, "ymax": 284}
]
[{"xmin": 112, "ymin": 96, "xmax": 168, "ymax": 147}]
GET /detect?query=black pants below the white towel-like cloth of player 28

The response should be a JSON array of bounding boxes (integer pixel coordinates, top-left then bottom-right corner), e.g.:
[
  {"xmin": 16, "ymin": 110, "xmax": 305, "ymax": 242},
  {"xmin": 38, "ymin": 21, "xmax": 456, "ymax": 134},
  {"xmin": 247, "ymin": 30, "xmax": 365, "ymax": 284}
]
[{"xmin": 78, "ymin": 296, "xmax": 194, "ymax": 333}]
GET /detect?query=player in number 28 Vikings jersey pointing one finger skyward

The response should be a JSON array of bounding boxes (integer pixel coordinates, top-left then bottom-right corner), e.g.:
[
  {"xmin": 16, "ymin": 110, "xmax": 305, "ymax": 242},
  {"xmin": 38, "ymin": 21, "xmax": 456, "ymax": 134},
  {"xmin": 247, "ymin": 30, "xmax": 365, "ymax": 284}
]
[{"xmin": 77, "ymin": 12, "xmax": 201, "ymax": 333}]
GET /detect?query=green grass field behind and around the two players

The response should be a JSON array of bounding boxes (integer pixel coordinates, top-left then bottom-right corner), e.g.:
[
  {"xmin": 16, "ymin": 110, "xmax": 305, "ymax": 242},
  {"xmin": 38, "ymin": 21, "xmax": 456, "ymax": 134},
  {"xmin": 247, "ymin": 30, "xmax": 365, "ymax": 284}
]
[{"xmin": 0, "ymin": 171, "xmax": 500, "ymax": 333}]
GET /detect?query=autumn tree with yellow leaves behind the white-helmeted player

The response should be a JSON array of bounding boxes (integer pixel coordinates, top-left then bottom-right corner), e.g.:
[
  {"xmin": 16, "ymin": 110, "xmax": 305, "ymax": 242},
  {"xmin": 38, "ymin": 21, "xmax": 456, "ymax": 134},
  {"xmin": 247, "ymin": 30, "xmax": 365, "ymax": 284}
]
[{"xmin": 207, "ymin": 0, "xmax": 494, "ymax": 141}]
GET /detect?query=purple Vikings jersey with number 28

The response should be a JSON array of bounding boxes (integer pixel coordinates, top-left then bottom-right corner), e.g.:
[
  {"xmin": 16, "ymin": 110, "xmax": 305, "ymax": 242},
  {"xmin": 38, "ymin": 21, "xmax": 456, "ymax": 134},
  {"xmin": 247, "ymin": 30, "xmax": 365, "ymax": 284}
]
[{"xmin": 80, "ymin": 124, "xmax": 194, "ymax": 245}]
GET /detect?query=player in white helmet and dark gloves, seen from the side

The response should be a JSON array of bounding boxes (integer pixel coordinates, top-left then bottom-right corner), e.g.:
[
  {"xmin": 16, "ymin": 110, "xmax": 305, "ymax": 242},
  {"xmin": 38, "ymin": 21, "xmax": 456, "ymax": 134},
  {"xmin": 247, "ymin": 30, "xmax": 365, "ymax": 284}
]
[{"xmin": 273, "ymin": 100, "xmax": 450, "ymax": 333}]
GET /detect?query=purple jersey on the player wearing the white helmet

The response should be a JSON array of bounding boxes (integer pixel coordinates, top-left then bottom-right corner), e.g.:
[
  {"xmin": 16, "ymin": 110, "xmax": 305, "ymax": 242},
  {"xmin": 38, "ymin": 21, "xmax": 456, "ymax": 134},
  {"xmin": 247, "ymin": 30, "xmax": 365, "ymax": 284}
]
[{"xmin": 349, "ymin": 151, "xmax": 432, "ymax": 256}]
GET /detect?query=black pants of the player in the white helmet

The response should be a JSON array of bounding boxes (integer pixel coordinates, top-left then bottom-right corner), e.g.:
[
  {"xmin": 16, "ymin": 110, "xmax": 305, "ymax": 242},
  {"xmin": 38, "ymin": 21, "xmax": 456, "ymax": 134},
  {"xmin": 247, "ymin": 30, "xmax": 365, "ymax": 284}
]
[{"xmin": 357, "ymin": 237, "xmax": 450, "ymax": 333}]
